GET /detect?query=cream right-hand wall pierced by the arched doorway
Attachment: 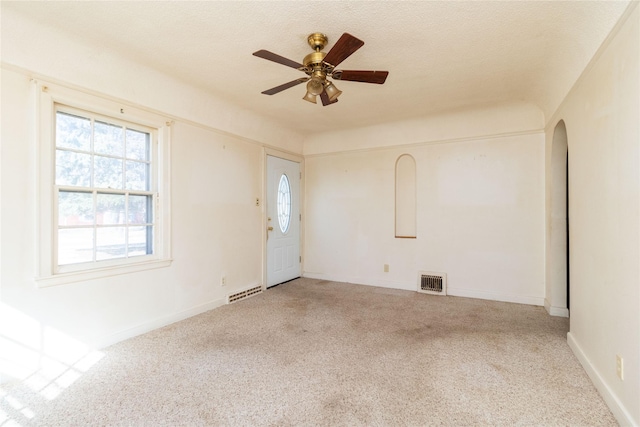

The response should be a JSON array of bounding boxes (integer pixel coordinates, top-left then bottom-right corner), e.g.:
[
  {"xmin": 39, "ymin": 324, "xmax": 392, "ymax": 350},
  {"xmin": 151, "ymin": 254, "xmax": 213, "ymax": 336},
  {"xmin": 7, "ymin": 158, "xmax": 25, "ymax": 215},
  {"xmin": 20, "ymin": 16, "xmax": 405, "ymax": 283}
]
[{"xmin": 546, "ymin": 3, "xmax": 640, "ymax": 425}]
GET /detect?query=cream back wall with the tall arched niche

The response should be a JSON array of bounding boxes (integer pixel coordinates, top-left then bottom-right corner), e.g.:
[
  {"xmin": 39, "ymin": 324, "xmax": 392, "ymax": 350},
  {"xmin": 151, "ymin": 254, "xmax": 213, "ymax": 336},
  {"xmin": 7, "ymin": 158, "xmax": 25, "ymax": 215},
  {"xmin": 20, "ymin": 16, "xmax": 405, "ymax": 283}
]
[{"xmin": 304, "ymin": 105, "xmax": 544, "ymax": 305}]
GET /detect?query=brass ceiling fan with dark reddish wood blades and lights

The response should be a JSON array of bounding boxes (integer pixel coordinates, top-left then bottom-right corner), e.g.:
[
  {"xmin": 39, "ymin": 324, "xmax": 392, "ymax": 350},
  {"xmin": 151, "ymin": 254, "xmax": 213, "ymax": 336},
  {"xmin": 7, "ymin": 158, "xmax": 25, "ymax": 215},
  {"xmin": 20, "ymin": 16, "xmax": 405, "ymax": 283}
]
[{"xmin": 253, "ymin": 33, "xmax": 389, "ymax": 106}]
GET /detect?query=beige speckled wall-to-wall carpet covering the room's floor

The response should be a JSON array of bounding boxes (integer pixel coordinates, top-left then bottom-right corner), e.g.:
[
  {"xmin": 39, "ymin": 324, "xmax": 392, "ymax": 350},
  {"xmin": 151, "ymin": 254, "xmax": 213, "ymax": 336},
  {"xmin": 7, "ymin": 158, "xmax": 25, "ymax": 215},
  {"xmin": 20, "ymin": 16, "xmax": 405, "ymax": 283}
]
[{"xmin": 2, "ymin": 279, "xmax": 616, "ymax": 426}]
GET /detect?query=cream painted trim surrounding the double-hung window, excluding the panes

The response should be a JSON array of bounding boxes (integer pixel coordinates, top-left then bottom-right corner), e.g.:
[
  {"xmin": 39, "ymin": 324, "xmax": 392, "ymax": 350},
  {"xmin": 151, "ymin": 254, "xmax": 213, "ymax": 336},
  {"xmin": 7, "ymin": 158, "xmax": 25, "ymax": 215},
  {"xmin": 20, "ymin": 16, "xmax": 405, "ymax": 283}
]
[{"xmin": 33, "ymin": 81, "xmax": 172, "ymax": 287}]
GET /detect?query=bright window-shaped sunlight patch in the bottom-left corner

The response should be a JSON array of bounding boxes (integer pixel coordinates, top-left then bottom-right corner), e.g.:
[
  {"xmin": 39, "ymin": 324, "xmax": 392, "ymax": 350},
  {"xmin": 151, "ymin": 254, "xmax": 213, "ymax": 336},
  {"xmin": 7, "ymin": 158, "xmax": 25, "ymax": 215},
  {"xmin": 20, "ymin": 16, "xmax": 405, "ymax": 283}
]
[{"xmin": 0, "ymin": 303, "xmax": 104, "ymax": 426}]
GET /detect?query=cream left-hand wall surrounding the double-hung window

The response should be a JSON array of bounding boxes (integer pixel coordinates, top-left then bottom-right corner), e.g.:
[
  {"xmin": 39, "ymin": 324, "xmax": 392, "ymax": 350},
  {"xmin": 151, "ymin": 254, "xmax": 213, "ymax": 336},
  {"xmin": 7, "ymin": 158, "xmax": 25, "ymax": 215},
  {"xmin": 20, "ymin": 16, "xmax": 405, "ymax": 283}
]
[{"xmin": 0, "ymin": 5, "xmax": 302, "ymax": 382}]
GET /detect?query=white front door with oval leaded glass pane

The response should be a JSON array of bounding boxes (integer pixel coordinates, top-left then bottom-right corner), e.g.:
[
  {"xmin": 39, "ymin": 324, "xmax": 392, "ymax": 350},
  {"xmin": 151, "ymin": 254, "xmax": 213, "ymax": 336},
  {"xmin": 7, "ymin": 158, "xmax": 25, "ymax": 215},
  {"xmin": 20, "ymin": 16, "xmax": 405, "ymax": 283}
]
[{"xmin": 267, "ymin": 156, "xmax": 301, "ymax": 287}]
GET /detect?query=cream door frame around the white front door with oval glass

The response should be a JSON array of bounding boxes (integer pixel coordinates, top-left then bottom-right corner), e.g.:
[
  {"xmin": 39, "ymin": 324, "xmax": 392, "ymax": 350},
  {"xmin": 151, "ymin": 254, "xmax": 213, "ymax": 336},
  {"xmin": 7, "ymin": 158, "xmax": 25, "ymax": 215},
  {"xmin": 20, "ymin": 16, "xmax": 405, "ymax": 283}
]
[{"xmin": 260, "ymin": 147, "xmax": 305, "ymax": 291}]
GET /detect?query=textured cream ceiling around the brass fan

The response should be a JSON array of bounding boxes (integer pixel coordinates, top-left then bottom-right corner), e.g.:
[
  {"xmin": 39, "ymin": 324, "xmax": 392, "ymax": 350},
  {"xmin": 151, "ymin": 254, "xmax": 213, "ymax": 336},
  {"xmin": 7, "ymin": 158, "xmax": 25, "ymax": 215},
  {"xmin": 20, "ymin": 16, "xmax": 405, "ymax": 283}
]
[{"xmin": 2, "ymin": 1, "xmax": 629, "ymax": 133}]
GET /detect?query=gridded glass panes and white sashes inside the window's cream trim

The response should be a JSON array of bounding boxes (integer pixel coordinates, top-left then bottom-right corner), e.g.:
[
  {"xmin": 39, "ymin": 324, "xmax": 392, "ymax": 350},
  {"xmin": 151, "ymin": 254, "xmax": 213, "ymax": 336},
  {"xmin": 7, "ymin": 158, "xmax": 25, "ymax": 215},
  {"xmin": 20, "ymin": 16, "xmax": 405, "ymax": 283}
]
[{"xmin": 54, "ymin": 106, "xmax": 155, "ymax": 266}]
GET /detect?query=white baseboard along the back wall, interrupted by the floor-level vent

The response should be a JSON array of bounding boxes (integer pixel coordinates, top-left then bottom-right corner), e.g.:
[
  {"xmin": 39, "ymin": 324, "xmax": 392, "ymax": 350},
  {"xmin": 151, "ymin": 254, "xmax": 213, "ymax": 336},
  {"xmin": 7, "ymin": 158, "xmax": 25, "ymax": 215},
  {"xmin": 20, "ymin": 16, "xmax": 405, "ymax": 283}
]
[{"xmin": 303, "ymin": 272, "xmax": 544, "ymax": 306}]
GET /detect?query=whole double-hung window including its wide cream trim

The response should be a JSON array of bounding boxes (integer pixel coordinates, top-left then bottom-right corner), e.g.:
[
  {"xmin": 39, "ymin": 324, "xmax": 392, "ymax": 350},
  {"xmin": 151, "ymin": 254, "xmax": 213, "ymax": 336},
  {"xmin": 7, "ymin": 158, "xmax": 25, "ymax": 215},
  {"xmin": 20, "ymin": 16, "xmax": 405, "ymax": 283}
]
[{"xmin": 33, "ymin": 81, "xmax": 171, "ymax": 287}]
